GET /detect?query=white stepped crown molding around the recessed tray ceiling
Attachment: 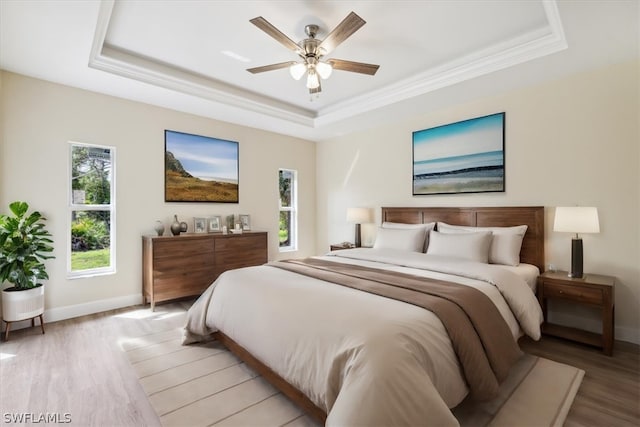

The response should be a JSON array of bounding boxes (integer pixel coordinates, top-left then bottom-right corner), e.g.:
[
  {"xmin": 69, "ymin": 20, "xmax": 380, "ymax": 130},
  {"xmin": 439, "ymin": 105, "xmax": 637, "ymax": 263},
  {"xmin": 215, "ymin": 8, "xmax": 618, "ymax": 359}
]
[{"xmin": 89, "ymin": 0, "xmax": 567, "ymax": 128}]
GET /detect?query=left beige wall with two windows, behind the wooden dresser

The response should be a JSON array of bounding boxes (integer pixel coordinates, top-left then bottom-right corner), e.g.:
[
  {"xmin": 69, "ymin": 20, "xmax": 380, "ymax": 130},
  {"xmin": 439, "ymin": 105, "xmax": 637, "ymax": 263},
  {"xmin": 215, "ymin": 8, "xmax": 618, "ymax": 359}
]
[{"xmin": 0, "ymin": 72, "xmax": 316, "ymax": 320}]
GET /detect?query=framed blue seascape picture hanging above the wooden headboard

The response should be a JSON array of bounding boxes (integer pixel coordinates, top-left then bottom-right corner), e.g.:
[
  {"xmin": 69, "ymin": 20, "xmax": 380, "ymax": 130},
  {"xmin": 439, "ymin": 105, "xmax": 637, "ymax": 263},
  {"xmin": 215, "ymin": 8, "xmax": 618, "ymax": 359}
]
[{"xmin": 412, "ymin": 113, "xmax": 505, "ymax": 196}]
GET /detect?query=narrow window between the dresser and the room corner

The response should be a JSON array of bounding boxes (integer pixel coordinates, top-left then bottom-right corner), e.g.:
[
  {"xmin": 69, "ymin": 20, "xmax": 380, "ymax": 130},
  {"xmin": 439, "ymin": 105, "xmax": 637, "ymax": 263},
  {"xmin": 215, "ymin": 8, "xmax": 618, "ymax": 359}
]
[{"xmin": 278, "ymin": 169, "xmax": 298, "ymax": 252}]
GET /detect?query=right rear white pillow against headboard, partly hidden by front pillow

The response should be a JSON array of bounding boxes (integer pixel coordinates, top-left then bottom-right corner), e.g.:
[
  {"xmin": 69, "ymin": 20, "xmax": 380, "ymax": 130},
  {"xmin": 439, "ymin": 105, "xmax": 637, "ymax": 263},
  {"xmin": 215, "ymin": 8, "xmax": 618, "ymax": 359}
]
[{"xmin": 438, "ymin": 222, "xmax": 527, "ymax": 266}]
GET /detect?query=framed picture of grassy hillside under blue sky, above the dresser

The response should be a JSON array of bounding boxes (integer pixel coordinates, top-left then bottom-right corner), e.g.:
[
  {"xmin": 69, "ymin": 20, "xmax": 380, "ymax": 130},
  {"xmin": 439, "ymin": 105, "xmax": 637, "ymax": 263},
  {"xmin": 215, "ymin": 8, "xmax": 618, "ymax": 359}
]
[{"xmin": 164, "ymin": 130, "xmax": 239, "ymax": 203}]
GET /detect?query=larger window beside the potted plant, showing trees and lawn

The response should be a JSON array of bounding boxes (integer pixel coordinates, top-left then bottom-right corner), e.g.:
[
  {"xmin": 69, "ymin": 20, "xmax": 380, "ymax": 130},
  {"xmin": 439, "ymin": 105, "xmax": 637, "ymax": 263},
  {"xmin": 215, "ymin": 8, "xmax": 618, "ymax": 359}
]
[{"xmin": 67, "ymin": 142, "xmax": 116, "ymax": 277}]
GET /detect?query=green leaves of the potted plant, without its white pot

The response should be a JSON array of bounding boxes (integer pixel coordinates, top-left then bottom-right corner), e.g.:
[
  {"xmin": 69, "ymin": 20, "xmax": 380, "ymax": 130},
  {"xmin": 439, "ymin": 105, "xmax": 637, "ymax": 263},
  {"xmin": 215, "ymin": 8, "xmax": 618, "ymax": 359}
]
[{"xmin": 0, "ymin": 201, "xmax": 55, "ymax": 291}]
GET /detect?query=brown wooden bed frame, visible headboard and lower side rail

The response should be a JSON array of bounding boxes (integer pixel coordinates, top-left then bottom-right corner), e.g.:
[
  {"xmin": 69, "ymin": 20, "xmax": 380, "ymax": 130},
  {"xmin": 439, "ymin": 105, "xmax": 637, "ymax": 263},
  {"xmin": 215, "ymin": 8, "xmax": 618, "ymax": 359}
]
[{"xmin": 213, "ymin": 206, "xmax": 544, "ymax": 425}]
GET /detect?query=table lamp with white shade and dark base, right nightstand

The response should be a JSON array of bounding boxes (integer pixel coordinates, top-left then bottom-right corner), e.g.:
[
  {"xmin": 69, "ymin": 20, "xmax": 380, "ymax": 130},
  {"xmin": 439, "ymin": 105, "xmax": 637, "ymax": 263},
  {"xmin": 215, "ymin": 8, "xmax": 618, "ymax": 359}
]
[{"xmin": 553, "ymin": 206, "xmax": 600, "ymax": 278}]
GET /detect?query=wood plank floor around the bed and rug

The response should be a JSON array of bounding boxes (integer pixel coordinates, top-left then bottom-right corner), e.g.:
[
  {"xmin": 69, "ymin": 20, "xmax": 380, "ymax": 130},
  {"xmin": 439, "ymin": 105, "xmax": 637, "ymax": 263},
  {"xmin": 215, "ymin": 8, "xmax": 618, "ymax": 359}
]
[{"xmin": 0, "ymin": 301, "xmax": 640, "ymax": 426}]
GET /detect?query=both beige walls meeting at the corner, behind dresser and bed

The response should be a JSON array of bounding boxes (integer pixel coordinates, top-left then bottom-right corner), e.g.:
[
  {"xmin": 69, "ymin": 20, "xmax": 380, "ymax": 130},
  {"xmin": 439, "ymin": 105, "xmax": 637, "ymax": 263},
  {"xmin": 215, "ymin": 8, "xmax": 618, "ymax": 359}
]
[{"xmin": 0, "ymin": 63, "xmax": 640, "ymax": 342}]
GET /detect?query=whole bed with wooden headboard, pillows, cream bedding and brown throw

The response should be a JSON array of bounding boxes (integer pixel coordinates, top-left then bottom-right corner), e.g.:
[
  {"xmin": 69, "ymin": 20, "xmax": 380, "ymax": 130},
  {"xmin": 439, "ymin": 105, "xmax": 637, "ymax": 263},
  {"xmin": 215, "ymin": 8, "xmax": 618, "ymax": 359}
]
[{"xmin": 184, "ymin": 207, "xmax": 544, "ymax": 425}]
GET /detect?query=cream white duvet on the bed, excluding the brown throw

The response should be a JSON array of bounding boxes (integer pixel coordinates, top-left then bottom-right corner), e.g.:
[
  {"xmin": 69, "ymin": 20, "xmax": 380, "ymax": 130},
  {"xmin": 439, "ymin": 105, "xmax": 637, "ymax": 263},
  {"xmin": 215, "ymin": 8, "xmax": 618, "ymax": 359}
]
[{"xmin": 184, "ymin": 249, "xmax": 542, "ymax": 426}]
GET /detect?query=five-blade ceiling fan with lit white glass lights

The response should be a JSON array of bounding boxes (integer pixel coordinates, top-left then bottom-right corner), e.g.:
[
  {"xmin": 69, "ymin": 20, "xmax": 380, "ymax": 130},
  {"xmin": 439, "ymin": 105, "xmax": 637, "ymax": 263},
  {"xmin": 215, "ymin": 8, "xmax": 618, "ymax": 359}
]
[{"xmin": 247, "ymin": 12, "xmax": 380, "ymax": 94}]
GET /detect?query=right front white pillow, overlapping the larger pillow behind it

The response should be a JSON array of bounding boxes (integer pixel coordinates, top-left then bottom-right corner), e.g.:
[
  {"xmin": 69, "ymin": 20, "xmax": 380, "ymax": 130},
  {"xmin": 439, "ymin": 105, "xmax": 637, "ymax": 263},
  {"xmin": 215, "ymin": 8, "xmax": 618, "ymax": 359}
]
[{"xmin": 427, "ymin": 230, "xmax": 491, "ymax": 264}]
